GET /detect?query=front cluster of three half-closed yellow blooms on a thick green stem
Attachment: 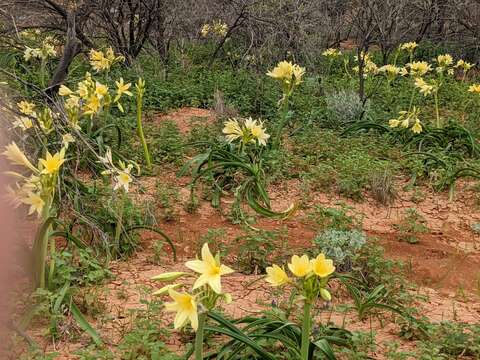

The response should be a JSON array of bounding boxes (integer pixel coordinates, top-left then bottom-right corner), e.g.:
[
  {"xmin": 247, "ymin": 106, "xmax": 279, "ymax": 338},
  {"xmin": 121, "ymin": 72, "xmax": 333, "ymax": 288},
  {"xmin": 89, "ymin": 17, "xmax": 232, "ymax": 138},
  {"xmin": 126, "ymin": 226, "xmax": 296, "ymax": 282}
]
[{"xmin": 265, "ymin": 254, "xmax": 335, "ymax": 301}]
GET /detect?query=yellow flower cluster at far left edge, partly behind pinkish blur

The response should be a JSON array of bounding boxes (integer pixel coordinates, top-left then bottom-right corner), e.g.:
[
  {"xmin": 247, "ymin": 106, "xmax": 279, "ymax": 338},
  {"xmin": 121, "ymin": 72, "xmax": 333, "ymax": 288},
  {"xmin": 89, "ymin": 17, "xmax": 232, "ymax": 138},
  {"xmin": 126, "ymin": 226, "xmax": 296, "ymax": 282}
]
[{"xmin": 3, "ymin": 142, "xmax": 65, "ymax": 216}]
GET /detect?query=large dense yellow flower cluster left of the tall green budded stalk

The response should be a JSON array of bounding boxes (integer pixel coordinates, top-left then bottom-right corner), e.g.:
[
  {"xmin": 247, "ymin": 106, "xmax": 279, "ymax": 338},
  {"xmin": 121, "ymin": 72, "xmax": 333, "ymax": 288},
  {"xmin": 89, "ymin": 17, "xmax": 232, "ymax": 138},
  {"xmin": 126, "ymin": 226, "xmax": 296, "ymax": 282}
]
[{"xmin": 58, "ymin": 72, "xmax": 133, "ymax": 122}]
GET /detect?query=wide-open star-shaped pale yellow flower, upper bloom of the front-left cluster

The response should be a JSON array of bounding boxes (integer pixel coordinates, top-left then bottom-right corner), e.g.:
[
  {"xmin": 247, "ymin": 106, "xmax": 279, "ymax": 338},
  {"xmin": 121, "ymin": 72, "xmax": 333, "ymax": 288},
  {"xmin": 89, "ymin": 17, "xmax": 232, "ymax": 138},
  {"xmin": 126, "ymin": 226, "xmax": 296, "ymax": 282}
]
[{"xmin": 185, "ymin": 243, "xmax": 234, "ymax": 294}]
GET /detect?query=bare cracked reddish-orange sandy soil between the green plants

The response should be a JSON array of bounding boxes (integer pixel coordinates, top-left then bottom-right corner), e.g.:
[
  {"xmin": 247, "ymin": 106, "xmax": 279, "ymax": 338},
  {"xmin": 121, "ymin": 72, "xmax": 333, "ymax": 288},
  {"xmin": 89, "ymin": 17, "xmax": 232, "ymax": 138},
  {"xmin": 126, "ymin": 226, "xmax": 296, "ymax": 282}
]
[{"xmin": 6, "ymin": 108, "xmax": 480, "ymax": 359}]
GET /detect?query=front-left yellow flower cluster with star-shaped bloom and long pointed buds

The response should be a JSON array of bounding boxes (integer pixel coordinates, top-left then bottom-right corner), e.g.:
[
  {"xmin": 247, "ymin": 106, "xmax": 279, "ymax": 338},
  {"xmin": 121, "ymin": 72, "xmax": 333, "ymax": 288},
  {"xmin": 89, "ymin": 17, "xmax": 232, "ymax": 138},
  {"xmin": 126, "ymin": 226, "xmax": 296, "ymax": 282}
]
[{"xmin": 152, "ymin": 243, "xmax": 234, "ymax": 331}]
